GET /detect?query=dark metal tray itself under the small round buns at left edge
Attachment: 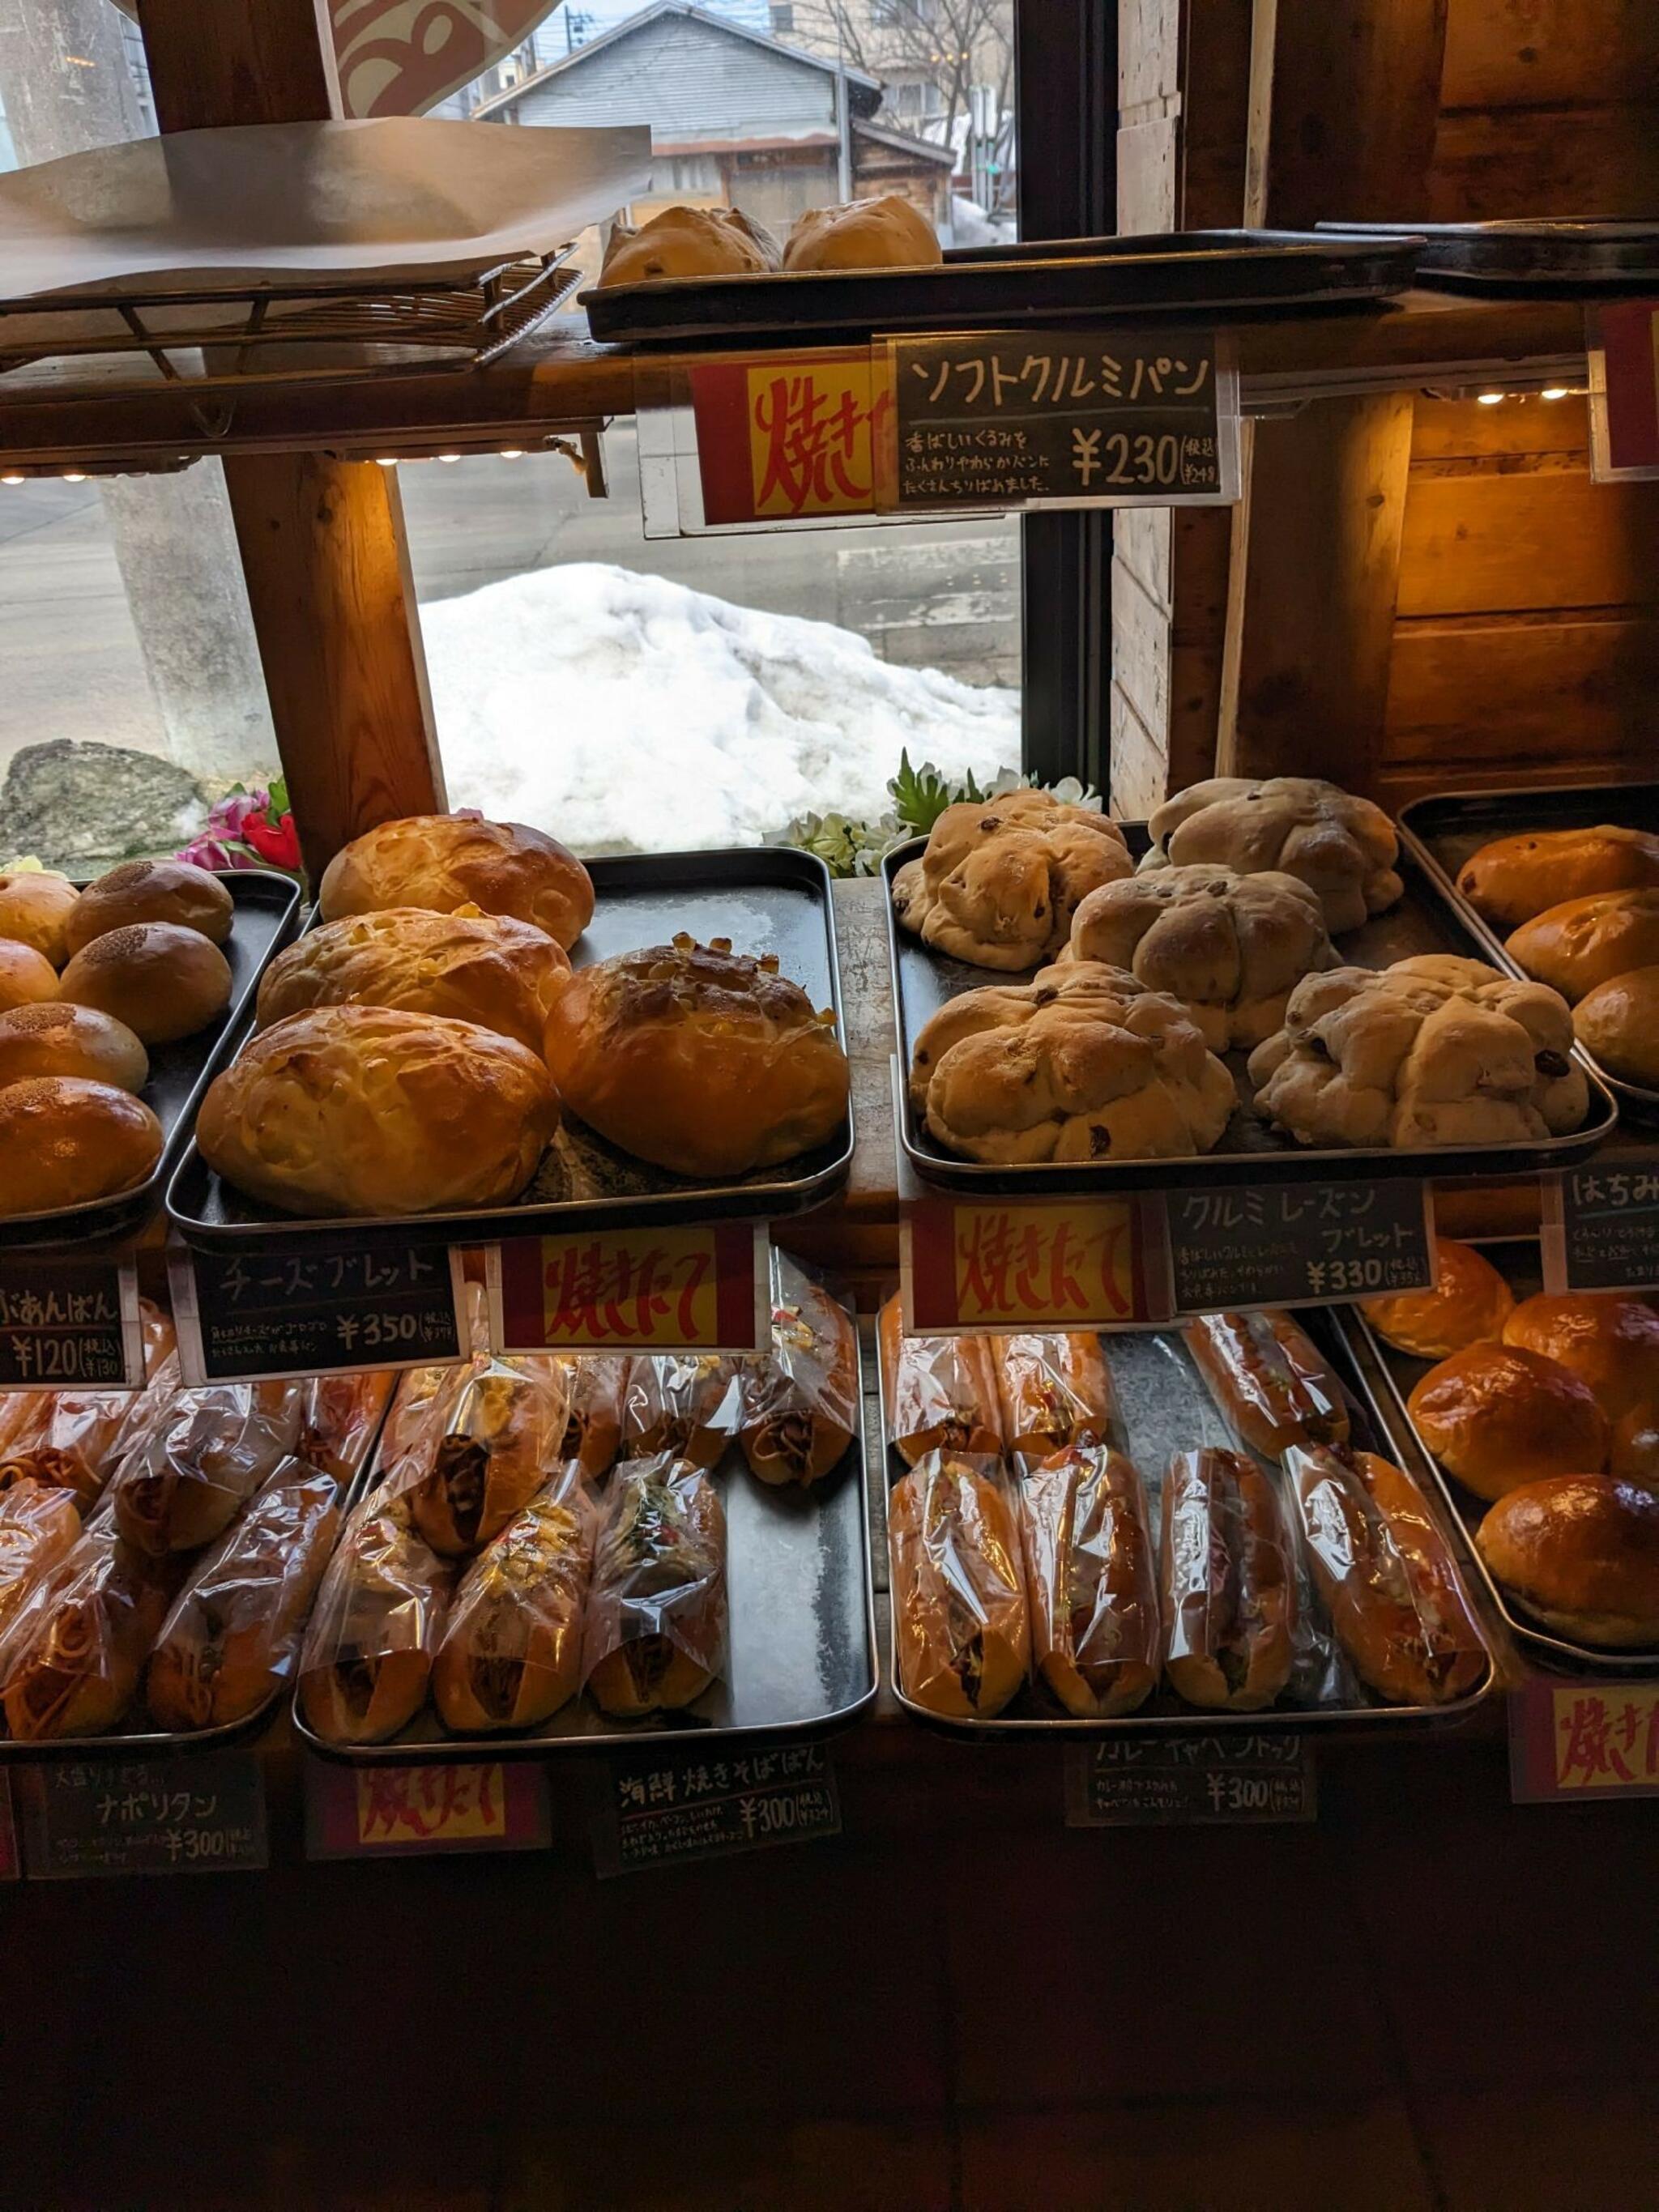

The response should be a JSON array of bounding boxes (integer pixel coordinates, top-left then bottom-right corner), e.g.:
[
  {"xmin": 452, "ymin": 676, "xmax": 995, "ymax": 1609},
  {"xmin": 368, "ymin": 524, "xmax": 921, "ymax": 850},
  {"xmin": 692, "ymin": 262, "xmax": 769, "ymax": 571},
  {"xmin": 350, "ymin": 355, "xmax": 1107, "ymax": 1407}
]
[{"xmin": 0, "ymin": 869, "xmax": 299, "ymax": 1254}]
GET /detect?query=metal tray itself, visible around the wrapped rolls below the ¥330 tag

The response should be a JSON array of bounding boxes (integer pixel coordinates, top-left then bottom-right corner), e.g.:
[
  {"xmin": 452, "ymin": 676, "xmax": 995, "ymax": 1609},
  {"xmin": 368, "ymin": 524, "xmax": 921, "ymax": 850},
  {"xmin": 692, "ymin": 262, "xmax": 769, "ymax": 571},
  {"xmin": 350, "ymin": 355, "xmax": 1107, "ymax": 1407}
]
[{"xmin": 876, "ymin": 1307, "xmax": 1495, "ymax": 1737}]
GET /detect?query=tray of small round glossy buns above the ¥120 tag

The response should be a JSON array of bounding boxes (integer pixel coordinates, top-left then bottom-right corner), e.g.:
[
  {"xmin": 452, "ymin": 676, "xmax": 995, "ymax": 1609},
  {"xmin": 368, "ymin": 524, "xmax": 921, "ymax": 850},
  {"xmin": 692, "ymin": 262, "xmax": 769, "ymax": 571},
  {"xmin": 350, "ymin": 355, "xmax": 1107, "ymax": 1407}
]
[{"xmin": 0, "ymin": 860, "xmax": 299, "ymax": 1250}]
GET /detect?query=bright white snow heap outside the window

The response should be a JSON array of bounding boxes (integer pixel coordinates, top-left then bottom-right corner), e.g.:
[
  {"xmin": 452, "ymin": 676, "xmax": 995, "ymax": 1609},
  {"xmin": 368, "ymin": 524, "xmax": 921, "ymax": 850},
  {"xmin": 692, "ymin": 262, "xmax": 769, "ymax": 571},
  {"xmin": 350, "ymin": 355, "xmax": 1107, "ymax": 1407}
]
[{"xmin": 420, "ymin": 562, "xmax": 1020, "ymax": 854}]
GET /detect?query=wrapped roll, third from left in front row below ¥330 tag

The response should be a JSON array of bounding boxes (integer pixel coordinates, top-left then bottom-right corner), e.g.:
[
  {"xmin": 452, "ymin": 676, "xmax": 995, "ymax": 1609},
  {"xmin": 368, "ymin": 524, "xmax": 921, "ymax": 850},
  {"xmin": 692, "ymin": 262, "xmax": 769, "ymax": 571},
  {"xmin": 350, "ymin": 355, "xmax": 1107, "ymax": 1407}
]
[{"xmin": 1159, "ymin": 1447, "xmax": 1299, "ymax": 1712}]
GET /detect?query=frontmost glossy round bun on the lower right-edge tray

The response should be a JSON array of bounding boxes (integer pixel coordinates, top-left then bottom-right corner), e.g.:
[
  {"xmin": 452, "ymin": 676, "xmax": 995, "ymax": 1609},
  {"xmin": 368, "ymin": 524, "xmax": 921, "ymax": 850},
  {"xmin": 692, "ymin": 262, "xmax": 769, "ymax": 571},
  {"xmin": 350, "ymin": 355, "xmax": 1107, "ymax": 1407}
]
[{"xmin": 1475, "ymin": 1476, "xmax": 1659, "ymax": 1650}]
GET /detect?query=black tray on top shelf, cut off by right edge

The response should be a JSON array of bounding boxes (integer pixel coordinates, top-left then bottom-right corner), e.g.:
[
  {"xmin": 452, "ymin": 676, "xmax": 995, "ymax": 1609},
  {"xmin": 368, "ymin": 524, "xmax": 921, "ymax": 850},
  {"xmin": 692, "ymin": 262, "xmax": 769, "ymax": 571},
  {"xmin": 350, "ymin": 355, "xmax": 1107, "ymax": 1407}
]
[{"xmin": 1318, "ymin": 217, "xmax": 1659, "ymax": 299}]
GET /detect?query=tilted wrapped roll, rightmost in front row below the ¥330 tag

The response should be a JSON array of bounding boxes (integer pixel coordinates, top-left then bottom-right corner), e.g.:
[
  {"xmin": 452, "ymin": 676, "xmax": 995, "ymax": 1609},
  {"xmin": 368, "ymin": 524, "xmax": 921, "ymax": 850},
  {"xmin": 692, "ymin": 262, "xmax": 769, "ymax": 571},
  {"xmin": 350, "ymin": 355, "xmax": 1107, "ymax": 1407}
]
[{"xmin": 1286, "ymin": 1444, "xmax": 1491, "ymax": 1706}]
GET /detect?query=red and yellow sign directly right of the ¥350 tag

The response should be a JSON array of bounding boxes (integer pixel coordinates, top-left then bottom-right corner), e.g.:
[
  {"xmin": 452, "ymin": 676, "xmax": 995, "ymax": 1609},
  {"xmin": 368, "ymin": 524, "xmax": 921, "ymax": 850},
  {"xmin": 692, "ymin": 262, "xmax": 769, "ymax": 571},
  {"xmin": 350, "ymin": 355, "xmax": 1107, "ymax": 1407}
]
[{"xmin": 484, "ymin": 1221, "xmax": 772, "ymax": 1352}]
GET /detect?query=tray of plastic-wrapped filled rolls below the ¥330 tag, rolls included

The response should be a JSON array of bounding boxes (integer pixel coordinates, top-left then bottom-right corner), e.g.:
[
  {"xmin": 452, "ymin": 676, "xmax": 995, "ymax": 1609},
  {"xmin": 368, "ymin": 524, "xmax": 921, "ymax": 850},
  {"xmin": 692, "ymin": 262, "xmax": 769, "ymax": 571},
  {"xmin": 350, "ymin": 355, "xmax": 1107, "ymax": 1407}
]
[{"xmin": 881, "ymin": 1301, "xmax": 1493, "ymax": 1737}]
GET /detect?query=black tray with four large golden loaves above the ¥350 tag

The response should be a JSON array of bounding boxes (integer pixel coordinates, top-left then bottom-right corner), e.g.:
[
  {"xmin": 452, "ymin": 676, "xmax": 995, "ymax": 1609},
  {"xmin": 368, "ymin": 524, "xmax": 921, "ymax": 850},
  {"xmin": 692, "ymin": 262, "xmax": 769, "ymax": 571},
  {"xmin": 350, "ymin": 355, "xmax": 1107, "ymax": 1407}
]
[{"xmin": 168, "ymin": 845, "xmax": 854, "ymax": 1252}]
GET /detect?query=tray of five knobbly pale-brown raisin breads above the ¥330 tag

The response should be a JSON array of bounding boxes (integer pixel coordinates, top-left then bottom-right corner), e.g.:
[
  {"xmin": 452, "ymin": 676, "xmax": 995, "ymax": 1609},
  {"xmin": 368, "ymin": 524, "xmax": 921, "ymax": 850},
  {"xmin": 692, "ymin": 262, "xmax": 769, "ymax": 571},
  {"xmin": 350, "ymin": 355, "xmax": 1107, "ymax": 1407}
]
[{"xmin": 883, "ymin": 777, "xmax": 1617, "ymax": 1195}]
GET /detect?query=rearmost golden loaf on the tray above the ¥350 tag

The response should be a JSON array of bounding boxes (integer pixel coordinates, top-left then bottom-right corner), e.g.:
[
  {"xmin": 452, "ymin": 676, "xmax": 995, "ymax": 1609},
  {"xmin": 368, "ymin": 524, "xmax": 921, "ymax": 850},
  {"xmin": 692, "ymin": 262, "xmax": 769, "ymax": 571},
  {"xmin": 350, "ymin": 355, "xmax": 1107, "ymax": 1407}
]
[{"xmin": 318, "ymin": 814, "xmax": 593, "ymax": 947}]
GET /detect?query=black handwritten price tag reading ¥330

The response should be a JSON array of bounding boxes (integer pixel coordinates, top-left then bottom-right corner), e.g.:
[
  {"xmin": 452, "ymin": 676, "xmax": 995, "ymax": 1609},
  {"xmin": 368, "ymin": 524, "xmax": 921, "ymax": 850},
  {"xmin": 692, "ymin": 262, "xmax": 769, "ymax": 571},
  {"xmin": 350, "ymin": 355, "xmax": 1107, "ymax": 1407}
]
[{"xmin": 1166, "ymin": 1177, "xmax": 1433, "ymax": 1314}]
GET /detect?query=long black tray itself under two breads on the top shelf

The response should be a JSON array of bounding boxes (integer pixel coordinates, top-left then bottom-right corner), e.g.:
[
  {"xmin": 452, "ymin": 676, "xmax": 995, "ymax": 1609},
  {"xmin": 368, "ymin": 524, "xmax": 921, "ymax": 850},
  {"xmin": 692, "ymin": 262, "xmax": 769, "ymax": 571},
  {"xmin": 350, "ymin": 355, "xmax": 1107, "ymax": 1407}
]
[{"xmin": 578, "ymin": 230, "xmax": 1418, "ymax": 345}]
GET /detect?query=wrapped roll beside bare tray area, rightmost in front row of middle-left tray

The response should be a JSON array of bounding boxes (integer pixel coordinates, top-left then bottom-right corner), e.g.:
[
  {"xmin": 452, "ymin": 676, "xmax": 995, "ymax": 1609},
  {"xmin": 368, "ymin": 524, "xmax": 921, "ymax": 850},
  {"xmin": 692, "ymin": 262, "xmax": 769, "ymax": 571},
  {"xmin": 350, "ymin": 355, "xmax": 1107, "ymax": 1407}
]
[{"xmin": 582, "ymin": 1453, "xmax": 726, "ymax": 1719}]
